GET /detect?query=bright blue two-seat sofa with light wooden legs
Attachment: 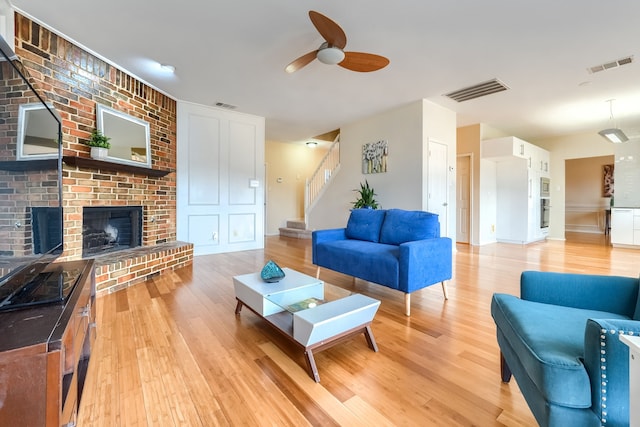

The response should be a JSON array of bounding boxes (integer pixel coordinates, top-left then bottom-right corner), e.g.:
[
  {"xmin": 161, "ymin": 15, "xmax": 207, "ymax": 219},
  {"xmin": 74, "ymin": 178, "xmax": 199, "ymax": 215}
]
[{"xmin": 312, "ymin": 209, "xmax": 453, "ymax": 316}]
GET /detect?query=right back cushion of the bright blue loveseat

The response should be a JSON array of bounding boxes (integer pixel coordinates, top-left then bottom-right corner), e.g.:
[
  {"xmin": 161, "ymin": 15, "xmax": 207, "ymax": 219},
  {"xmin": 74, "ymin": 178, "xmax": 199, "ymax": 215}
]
[{"xmin": 380, "ymin": 209, "xmax": 440, "ymax": 245}]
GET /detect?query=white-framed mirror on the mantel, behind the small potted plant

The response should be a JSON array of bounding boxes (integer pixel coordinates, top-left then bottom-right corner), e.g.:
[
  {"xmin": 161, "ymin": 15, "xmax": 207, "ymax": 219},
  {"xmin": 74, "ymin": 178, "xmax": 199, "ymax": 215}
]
[{"xmin": 96, "ymin": 104, "xmax": 151, "ymax": 168}]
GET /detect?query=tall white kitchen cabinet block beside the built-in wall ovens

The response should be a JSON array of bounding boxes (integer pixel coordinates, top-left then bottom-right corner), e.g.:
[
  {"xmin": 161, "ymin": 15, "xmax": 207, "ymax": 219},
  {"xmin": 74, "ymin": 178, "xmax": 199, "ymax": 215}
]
[{"xmin": 481, "ymin": 137, "xmax": 549, "ymax": 244}]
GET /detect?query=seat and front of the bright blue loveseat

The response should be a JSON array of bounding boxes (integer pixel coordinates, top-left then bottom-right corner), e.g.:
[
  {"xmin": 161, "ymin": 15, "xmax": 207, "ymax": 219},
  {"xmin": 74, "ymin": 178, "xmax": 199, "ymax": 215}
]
[{"xmin": 315, "ymin": 240, "xmax": 400, "ymax": 289}]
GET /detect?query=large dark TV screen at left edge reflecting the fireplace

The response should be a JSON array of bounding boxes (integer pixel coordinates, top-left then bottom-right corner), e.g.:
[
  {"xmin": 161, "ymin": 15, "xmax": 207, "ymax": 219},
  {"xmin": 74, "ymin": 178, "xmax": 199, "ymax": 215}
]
[{"xmin": 0, "ymin": 37, "xmax": 66, "ymax": 309}]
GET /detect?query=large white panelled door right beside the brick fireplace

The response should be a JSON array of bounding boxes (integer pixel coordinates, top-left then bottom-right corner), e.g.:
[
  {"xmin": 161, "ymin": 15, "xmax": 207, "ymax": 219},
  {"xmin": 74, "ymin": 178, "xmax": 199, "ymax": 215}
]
[{"xmin": 176, "ymin": 103, "xmax": 265, "ymax": 255}]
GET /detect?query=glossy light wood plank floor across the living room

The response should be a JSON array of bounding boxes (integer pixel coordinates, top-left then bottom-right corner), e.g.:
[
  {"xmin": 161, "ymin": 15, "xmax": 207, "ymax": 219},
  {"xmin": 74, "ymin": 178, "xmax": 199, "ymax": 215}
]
[{"xmin": 79, "ymin": 234, "xmax": 640, "ymax": 426}]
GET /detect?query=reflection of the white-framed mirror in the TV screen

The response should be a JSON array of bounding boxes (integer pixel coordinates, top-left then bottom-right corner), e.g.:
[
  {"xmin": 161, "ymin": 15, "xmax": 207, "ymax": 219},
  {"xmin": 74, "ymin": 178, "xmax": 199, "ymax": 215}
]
[{"xmin": 16, "ymin": 102, "xmax": 59, "ymax": 160}]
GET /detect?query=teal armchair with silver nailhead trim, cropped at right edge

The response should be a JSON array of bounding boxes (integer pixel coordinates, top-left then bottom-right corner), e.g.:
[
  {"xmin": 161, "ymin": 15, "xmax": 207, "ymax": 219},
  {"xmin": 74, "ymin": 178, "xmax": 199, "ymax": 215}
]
[{"xmin": 491, "ymin": 271, "xmax": 640, "ymax": 427}]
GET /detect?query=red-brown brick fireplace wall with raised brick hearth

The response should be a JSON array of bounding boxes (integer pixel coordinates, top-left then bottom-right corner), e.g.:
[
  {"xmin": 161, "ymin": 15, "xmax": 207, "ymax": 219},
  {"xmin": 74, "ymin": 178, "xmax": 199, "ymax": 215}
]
[{"xmin": 15, "ymin": 13, "xmax": 193, "ymax": 292}]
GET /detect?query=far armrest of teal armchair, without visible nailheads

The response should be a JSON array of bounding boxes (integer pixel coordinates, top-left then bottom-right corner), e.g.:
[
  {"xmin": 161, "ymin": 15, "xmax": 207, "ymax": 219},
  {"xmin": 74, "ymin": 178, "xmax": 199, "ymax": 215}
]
[{"xmin": 520, "ymin": 271, "xmax": 638, "ymax": 318}]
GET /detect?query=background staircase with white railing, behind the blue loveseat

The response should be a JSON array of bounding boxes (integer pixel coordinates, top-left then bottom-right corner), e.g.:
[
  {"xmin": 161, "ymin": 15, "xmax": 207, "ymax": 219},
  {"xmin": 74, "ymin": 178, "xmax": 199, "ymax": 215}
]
[{"xmin": 279, "ymin": 134, "xmax": 340, "ymax": 239}]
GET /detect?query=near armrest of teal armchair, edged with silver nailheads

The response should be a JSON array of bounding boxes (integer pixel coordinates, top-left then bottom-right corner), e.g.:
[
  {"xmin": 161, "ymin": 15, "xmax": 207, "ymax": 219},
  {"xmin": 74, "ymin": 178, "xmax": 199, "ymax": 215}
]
[{"xmin": 584, "ymin": 319, "xmax": 640, "ymax": 426}]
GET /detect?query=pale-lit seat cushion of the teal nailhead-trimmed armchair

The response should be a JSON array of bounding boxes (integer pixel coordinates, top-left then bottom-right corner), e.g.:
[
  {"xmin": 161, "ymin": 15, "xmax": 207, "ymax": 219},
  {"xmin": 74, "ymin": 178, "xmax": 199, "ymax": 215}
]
[{"xmin": 491, "ymin": 294, "xmax": 628, "ymax": 408}]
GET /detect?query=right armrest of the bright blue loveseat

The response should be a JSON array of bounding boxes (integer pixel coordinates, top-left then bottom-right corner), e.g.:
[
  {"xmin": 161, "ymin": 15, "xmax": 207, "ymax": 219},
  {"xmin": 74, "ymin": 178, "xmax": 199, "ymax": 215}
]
[{"xmin": 399, "ymin": 237, "xmax": 453, "ymax": 293}]
